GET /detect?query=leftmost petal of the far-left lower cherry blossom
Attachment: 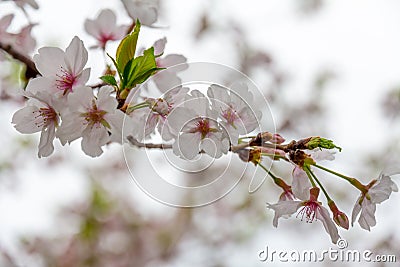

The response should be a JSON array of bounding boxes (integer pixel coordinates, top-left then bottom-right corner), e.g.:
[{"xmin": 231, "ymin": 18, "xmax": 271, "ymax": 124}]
[{"xmin": 12, "ymin": 106, "xmax": 42, "ymax": 134}]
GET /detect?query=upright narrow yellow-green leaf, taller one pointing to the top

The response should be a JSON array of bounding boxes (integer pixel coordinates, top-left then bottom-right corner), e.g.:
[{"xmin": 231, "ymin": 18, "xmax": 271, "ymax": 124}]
[{"xmin": 115, "ymin": 20, "xmax": 140, "ymax": 74}]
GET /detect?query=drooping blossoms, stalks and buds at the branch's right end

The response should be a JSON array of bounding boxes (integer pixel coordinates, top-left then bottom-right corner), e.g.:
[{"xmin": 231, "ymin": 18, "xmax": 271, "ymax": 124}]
[{"xmin": 237, "ymin": 136, "xmax": 398, "ymax": 243}]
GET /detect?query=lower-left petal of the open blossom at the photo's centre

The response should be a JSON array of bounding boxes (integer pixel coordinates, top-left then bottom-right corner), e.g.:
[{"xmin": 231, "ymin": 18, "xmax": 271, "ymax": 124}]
[{"xmin": 173, "ymin": 133, "xmax": 201, "ymax": 160}]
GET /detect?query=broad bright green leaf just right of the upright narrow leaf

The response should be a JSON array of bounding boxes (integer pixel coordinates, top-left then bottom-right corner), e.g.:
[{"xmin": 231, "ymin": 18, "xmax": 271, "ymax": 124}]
[{"xmin": 122, "ymin": 47, "xmax": 160, "ymax": 88}]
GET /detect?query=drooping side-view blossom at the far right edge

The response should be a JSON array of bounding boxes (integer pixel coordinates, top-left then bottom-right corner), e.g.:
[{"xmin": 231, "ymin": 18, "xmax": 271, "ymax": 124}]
[{"xmin": 351, "ymin": 174, "xmax": 398, "ymax": 231}]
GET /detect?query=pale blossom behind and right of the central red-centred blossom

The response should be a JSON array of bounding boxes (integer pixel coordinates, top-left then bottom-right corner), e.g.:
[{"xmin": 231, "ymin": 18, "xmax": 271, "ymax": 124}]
[{"xmin": 207, "ymin": 83, "xmax": 261, "ymax": 145}]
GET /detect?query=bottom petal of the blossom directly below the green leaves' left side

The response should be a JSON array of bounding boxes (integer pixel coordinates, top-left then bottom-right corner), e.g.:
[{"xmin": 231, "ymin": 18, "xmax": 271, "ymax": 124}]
[{"xmin": 81, "ymin": 125, "xmax": 110, "ymax": 157}]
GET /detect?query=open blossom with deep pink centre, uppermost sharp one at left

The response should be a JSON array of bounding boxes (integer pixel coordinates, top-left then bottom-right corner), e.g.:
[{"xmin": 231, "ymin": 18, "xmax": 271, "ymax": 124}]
[{"xmin": 27, "ymin": 36, "xmax": 90, "ymax": 98}]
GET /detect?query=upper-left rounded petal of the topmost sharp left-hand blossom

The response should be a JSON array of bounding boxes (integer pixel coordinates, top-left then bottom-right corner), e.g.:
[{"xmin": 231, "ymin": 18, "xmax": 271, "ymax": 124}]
[{"xmin": 33, "ymin": 47, "xmax": 64, "ymax": 77}]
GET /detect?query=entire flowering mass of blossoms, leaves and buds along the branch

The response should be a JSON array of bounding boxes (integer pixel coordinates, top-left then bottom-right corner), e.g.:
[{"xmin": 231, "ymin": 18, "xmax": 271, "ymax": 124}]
[{"xmin": 0, "ymin": 0, "xmax": 398, "ymax": 243}]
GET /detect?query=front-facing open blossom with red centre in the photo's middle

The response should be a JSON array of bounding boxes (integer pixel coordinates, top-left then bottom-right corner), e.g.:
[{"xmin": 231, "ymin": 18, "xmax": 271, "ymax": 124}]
[{"xmin": 168, "ymin": 90, "xmax": 229, "ymax": 159}]
